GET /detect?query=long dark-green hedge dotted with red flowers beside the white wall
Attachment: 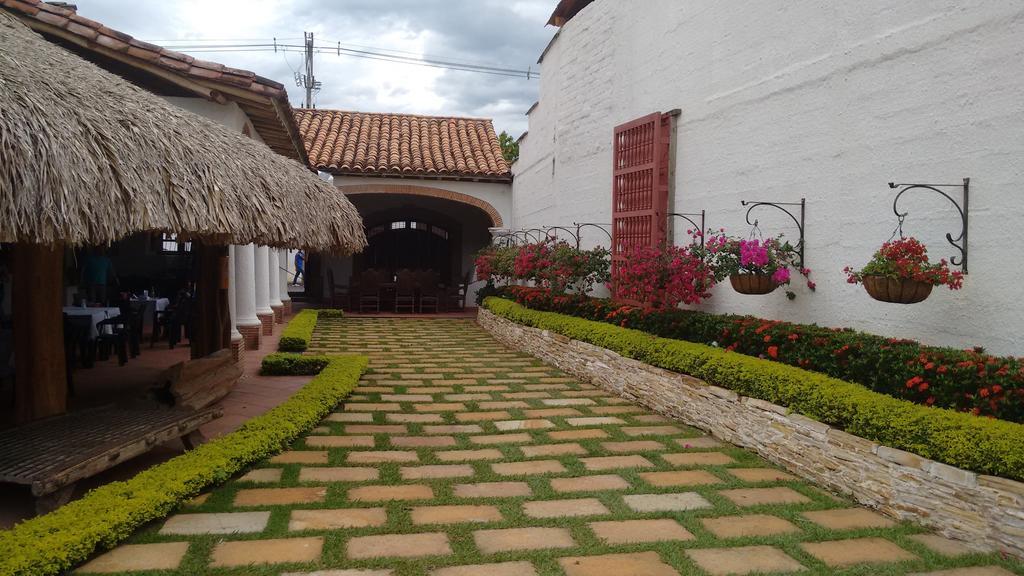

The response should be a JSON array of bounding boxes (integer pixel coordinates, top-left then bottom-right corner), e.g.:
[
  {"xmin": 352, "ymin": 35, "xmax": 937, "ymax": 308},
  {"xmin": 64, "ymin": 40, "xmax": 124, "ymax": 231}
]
[{"xmin": 504, "ymin": 287, "xmax": 1024, "ymax": 422}]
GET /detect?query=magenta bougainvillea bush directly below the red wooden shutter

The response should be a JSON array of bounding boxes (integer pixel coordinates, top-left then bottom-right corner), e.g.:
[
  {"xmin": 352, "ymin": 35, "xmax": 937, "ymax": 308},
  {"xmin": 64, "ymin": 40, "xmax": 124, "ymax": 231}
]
[{"xmin": 608, "ymin": 240, "xmax": 721, "ymax": 307}]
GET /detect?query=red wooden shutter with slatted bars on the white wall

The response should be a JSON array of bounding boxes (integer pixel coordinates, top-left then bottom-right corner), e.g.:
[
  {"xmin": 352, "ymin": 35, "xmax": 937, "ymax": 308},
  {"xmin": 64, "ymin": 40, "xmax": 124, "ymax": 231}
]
[{"xmin": 611, "ymin": 112, "xmax": 672, "ymax": 301}]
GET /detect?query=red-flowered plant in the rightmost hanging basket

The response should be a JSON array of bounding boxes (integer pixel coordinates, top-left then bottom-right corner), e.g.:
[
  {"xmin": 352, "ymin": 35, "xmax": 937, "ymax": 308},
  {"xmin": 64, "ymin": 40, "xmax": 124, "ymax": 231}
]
[{"xmin": 843, "ymin": 238, "xmax": 964, "ymax": 290}]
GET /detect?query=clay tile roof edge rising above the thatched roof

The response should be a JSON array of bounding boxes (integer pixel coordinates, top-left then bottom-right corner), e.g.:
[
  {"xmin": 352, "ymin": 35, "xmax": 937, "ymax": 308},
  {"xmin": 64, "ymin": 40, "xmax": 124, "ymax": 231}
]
[{"xmin": 0, "ymin": 0, "xmax": 306, "ymax": 163}]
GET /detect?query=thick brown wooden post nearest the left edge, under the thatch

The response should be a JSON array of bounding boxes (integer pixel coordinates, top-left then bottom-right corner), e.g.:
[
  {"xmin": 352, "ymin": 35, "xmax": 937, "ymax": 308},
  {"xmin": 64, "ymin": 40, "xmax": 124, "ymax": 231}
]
[{"xmin": 11, "ymin": 243, "xmax": 68, "ymax": 423}]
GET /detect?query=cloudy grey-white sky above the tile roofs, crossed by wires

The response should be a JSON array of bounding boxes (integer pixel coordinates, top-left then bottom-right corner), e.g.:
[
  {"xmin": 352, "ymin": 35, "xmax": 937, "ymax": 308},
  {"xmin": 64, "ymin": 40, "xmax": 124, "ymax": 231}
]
[{"xmin": 76, "ymin": 0, "xmax": 557, "ymax": 136}]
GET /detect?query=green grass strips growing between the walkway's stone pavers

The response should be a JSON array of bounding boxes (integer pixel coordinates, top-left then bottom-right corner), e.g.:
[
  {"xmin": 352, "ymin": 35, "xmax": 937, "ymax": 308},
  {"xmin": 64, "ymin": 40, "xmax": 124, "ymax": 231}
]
[{"xmin": 94, "ymin": 321, "xmax": 1024, "ymax": 576}]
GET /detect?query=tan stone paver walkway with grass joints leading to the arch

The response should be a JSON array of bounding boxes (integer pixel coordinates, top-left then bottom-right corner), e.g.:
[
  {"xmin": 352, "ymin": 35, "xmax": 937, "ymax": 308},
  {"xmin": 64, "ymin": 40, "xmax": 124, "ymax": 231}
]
[{"xmin": 75, "ymin": 318, "xmax": 1022, "ymax": 576}]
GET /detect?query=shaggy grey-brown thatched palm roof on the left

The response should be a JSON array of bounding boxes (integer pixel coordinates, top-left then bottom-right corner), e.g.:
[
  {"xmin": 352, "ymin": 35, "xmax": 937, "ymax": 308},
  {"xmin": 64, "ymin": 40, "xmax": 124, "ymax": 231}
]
[{"xmin": 0, "ymin": 10, "xmax": 366, "ymax": 252}]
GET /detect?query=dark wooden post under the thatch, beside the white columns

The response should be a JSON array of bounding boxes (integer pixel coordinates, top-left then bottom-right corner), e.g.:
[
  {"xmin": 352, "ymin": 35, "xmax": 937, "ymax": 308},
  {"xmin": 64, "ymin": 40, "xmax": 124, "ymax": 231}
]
[{"xmin": 191, "ymin": 242, "xmax": 231, "ymax": 359}]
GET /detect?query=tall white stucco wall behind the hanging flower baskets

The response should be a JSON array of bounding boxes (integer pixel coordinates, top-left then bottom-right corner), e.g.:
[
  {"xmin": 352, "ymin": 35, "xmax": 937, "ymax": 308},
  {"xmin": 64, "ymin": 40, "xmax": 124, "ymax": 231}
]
[{"xmin": 513, "ymin": 0, "xmax": 1024, "ymax": 355}]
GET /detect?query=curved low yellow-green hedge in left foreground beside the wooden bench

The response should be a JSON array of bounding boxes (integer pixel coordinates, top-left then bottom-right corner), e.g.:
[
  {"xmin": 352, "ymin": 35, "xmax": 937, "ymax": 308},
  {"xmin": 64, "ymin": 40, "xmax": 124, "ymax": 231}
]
[{"xmin": 0, "ymin": 356, "xmax": 368, "ymax": 576}]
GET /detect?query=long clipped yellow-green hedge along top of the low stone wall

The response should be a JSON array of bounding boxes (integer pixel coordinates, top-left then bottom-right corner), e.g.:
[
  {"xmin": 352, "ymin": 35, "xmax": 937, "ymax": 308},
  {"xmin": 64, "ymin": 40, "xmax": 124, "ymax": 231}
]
[{"xmin": 483, "ymin": 297, "xmax": 1024, "ymax": 480}]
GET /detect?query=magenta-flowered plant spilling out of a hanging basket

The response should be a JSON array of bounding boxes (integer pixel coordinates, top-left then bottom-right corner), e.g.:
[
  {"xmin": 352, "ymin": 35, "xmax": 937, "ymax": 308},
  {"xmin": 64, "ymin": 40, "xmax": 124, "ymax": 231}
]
[{"xmin": 700, "ymin": 231, "xmax": 815, "ymax": 300}]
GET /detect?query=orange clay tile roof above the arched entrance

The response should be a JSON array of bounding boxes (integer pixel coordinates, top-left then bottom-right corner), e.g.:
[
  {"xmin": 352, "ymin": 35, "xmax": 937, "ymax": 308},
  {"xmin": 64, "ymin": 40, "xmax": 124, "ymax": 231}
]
[{"xmin": 295, "ymin": 109, "xmax": 512, "ymax": 181}]
